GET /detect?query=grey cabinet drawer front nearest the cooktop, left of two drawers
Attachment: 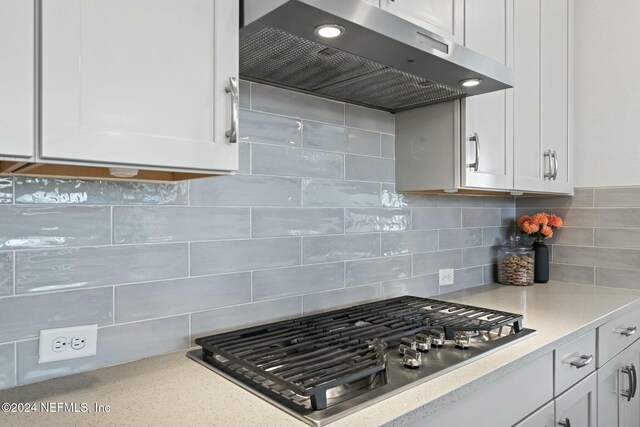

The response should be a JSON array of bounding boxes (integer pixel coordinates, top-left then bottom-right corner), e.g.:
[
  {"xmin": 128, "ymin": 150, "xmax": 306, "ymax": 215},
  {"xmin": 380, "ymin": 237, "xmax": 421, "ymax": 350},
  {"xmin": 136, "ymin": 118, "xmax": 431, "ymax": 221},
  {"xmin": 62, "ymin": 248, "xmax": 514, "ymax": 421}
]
[{"xmin": 554, "ymin": 330, "xmax": 596, "ymax": 396}]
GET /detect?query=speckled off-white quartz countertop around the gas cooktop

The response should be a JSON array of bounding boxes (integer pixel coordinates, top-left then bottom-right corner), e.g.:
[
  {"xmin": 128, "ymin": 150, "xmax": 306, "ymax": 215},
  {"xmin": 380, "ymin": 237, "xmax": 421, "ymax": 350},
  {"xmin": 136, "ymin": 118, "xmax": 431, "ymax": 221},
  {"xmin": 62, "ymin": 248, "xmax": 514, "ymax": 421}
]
[{"xmin": 0, "ymin": 282, "xmax": 640, "ymax": 427}]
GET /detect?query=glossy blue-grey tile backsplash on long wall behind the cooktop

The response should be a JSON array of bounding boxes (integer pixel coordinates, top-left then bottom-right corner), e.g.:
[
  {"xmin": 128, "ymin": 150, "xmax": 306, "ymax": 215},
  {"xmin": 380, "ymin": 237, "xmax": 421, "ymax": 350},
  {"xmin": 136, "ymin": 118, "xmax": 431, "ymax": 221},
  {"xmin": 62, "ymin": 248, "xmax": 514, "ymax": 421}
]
[{"xmin": 0, "ymin": 82, "xmax": 512, "ymax": 388}]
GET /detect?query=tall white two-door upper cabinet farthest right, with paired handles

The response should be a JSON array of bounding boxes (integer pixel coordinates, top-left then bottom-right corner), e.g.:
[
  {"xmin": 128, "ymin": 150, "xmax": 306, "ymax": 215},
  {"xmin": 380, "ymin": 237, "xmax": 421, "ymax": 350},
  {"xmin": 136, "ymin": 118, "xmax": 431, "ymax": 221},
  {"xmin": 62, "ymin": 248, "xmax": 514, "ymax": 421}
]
[{"xmin": 514, "ymin": 0, "xmax": 573, "ymax": 193}]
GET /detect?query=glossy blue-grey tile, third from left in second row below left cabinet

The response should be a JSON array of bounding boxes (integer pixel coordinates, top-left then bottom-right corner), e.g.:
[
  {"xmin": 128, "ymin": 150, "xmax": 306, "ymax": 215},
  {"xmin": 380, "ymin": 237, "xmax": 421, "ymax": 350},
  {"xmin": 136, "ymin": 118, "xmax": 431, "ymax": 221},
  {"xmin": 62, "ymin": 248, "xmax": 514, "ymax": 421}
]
[{"xmin": 251, "ymin": 208, "xmax": 344, "ymax": 237}]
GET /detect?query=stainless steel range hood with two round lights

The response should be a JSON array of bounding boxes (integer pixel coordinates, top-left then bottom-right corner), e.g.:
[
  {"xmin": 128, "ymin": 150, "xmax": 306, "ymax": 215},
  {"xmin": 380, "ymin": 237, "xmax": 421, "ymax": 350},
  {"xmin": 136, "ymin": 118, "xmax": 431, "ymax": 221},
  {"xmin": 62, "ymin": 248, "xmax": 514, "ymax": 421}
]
[{"xmin": 240, "ymin": 0, "xmax": 513, "ymax": 112}]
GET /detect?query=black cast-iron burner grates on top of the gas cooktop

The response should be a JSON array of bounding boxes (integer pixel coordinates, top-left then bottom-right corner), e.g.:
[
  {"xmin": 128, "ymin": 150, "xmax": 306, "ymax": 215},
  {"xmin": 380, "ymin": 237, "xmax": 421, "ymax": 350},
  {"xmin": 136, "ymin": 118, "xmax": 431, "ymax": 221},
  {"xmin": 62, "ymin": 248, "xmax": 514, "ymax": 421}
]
[{"xmin": 196, "ymin": 296, "xmax": 522, "ymax": 410}]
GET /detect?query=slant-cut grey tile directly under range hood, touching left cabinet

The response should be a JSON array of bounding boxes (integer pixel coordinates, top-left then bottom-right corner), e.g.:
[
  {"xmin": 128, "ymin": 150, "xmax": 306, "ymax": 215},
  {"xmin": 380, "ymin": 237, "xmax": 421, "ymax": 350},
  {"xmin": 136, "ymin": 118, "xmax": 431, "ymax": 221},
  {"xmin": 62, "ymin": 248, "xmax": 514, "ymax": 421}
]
[{"xmin": 251, "ymin": 83, "xmax": 344, "ymax": 125}]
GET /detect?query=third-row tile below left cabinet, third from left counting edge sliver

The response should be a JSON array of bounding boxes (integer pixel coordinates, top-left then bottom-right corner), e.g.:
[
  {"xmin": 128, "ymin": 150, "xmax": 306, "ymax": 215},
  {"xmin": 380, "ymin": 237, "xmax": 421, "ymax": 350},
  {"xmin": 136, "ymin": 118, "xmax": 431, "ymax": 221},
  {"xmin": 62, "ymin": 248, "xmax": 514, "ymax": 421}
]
[{"xmin": 191, "ymin": 237, "xmax": 302, "ymax": 276}]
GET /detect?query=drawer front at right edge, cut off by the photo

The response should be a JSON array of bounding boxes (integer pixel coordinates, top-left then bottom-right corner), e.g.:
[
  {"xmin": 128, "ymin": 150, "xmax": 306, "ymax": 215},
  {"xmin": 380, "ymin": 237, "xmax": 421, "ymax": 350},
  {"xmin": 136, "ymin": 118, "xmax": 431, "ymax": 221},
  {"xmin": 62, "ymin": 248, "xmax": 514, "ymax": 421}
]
[{"xmin": 598, "ymin": 307, "xmax": 640, "ymax": 367}]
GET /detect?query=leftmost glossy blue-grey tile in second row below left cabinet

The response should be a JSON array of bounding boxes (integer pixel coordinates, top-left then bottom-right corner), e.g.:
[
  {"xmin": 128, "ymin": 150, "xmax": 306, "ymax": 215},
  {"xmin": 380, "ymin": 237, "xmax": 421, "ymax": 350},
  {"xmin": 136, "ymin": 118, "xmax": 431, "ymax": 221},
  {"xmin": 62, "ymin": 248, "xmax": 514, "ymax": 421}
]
[{"xmin": 0, "ymin": 206, "xmax": 111, "ymax": 249}]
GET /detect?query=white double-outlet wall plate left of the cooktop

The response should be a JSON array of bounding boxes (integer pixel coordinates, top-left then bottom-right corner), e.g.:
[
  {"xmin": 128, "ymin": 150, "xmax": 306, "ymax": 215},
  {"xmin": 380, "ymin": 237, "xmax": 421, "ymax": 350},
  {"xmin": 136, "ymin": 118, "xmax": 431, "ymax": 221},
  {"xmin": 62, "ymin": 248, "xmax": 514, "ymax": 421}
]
[{"xmin": 38, "ymin": 325, "xmax": 98, "ymax": 363}]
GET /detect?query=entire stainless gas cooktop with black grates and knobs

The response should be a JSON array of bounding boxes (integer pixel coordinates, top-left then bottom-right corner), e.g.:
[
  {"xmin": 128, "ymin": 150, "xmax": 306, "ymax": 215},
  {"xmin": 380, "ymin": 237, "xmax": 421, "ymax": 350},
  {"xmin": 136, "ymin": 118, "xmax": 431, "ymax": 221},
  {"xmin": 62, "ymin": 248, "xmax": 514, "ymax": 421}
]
[{"xmin": 188, "ymin": 296, "xmax": 535, "ymax": 426}]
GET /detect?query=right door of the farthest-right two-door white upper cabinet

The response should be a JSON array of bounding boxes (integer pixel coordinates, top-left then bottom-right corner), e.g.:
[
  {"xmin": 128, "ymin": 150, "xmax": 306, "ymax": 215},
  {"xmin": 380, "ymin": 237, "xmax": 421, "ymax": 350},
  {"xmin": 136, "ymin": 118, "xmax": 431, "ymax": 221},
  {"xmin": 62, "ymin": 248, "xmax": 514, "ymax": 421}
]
[{"xmin": 540, "ymin": 0, "xmax": 572, "ymax": 193}]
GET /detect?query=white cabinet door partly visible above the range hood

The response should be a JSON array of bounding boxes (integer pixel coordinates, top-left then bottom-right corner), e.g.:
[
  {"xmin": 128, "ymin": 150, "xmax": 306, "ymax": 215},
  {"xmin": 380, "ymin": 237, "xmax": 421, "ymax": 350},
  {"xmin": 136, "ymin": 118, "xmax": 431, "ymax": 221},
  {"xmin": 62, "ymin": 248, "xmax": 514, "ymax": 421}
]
[{"xmin": 380, "ymin": 0, "xmax": 465, "ymax": 44}]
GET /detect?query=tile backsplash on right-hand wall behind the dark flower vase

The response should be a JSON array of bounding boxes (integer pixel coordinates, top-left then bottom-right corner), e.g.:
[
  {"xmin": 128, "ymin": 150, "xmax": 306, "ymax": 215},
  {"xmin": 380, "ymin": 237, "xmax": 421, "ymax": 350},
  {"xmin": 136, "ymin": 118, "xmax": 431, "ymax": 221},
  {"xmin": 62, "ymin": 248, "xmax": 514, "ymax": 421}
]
[{"xmin": 517, "ymin": 187, "xmax": 640, "ymax": 290}]
